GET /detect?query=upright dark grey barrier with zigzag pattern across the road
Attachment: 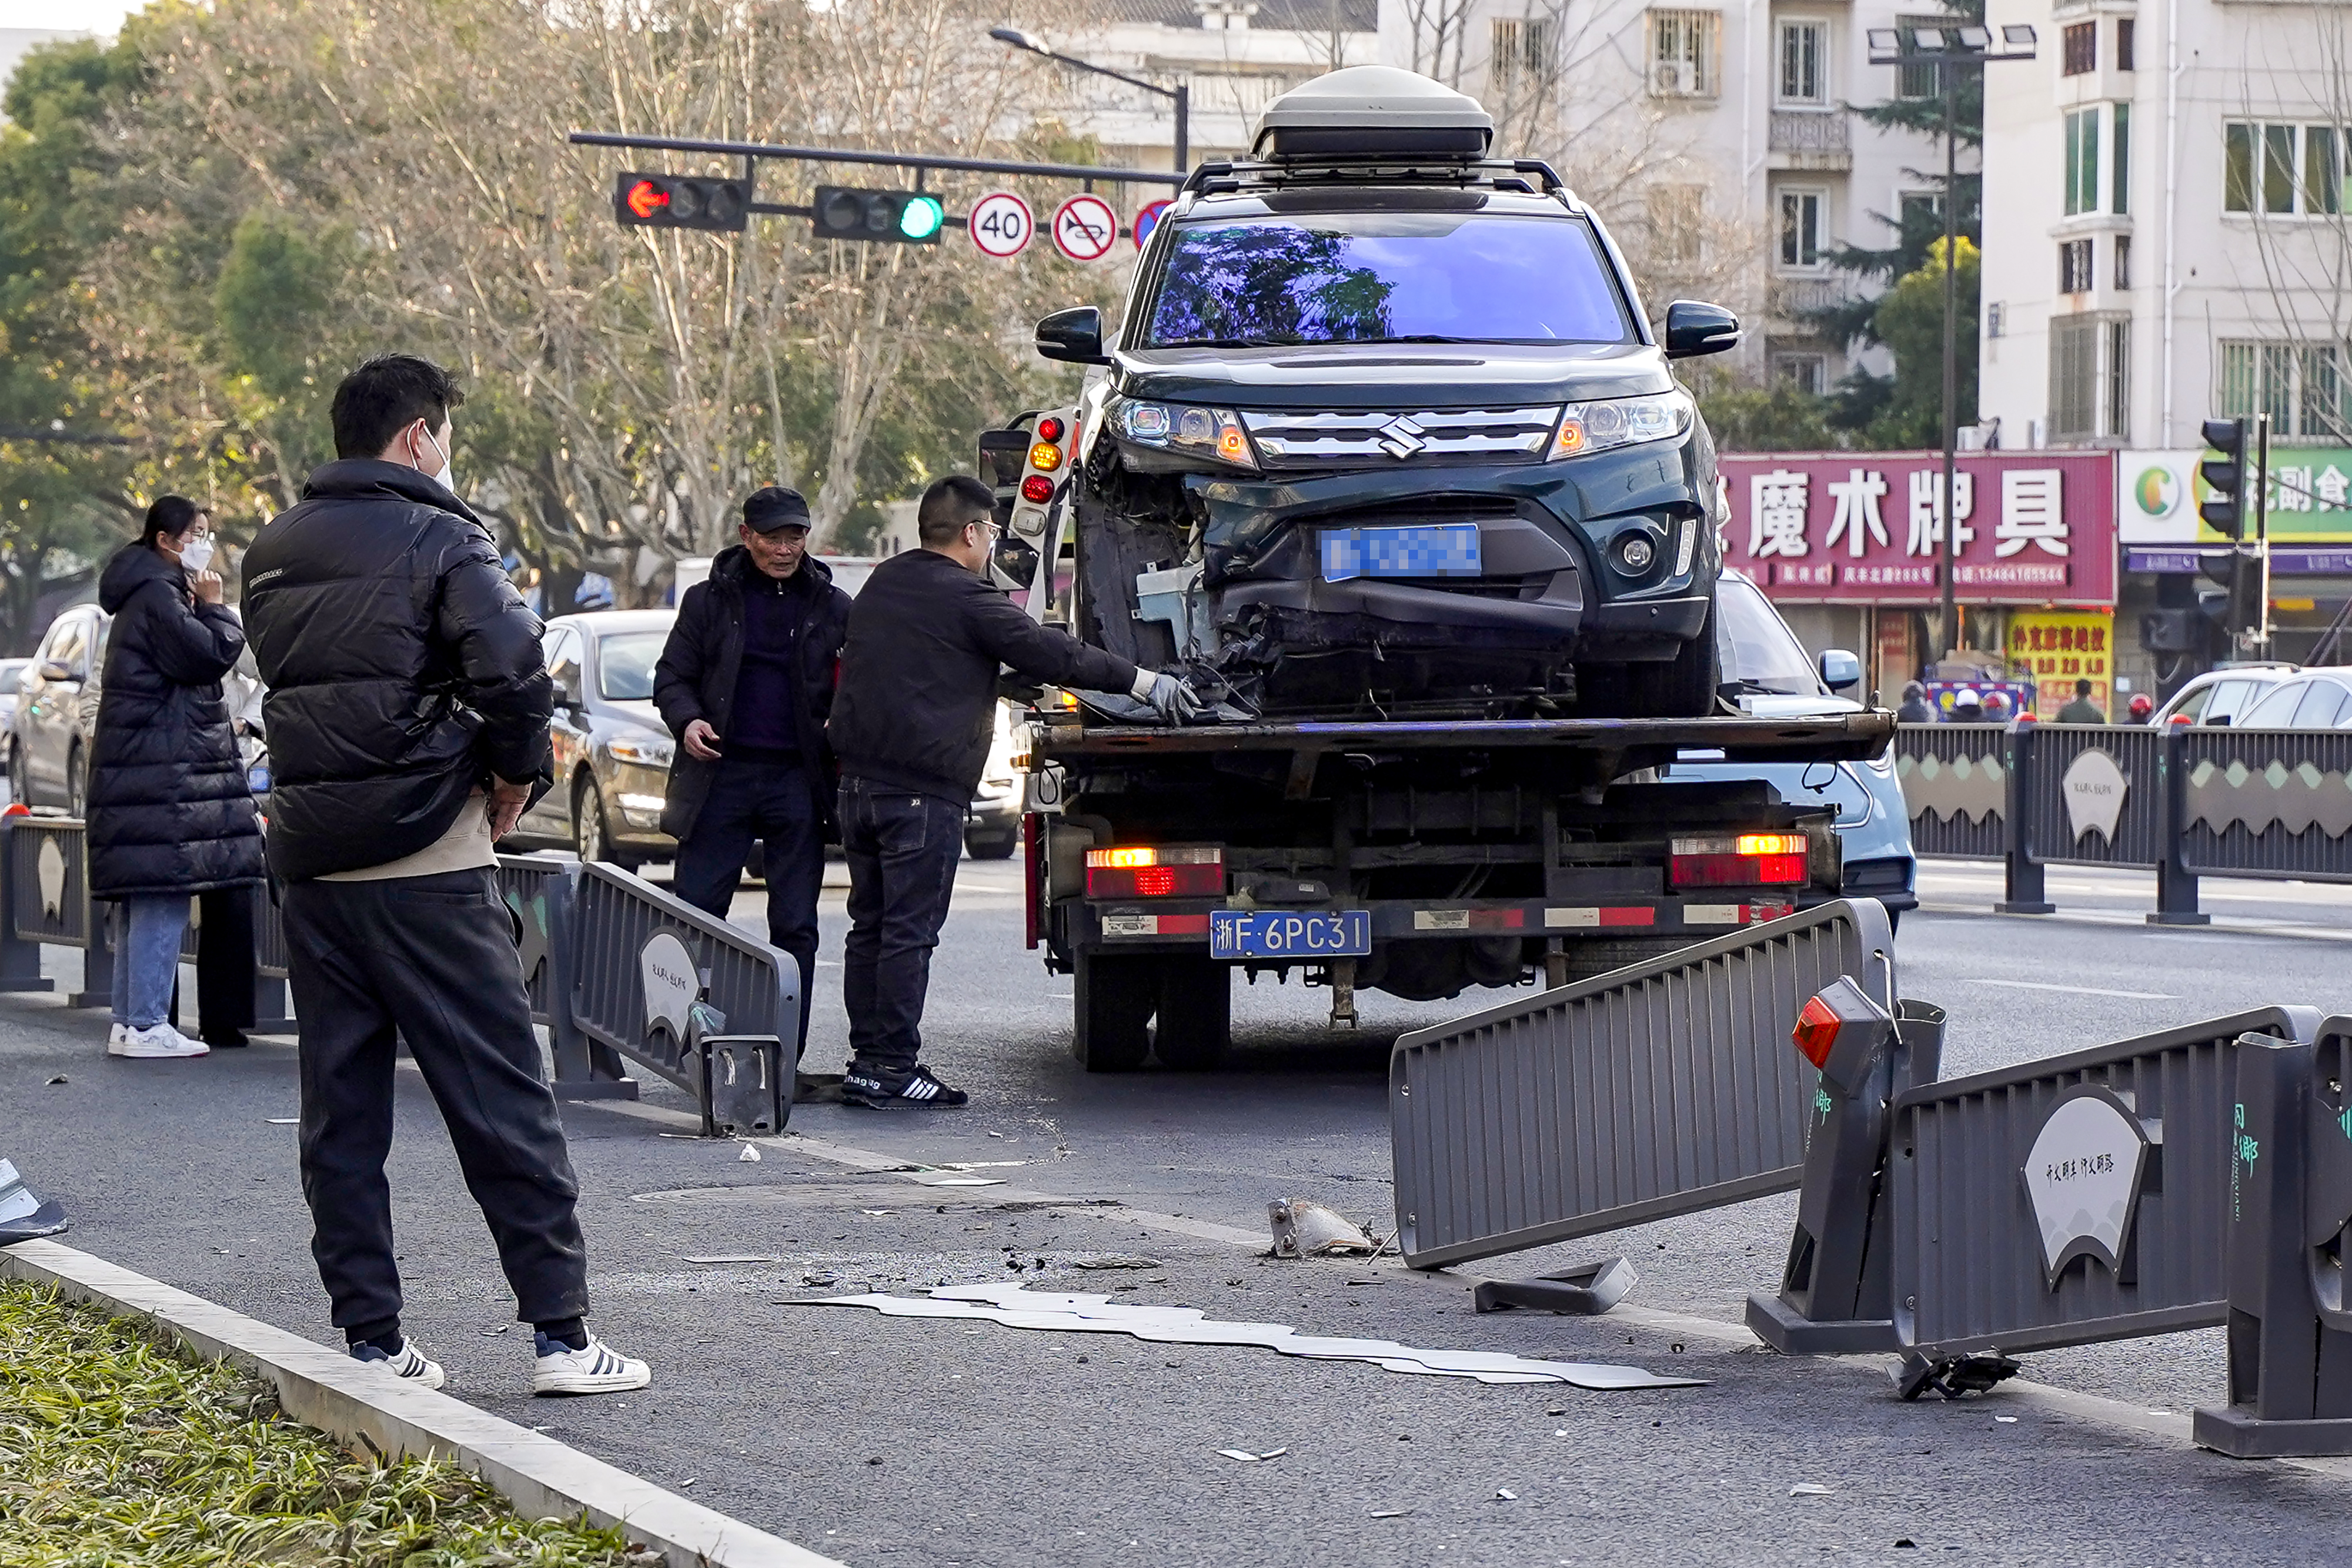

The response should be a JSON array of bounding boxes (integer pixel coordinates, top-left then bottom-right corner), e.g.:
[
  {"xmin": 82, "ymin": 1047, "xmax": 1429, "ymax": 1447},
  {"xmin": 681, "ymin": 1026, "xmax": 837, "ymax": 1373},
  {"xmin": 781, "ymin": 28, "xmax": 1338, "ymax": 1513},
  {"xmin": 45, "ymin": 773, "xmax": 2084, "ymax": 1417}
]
[{"xmin": 1896, "ymin": 720, "xmax": 2352, "ymax": 926}]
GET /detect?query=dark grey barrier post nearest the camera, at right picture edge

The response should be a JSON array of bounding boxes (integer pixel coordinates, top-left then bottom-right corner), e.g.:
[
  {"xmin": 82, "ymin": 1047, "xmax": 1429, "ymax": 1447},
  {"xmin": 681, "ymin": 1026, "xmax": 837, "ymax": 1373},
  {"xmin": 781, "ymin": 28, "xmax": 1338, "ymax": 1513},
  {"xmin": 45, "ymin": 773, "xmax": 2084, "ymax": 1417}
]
[{"xmin": 2192, "ymin": 1020, "xmax": 2352, "ymax": 1460}]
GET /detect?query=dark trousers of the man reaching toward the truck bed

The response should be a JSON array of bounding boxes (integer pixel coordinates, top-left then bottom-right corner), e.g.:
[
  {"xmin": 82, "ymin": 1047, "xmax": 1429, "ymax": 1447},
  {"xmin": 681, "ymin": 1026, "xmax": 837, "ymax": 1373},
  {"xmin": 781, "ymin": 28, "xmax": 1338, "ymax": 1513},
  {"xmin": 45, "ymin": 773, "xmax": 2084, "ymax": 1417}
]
[{"xmin": 842, "ymin": 778, "xmax": 964, "ymax": 1067}]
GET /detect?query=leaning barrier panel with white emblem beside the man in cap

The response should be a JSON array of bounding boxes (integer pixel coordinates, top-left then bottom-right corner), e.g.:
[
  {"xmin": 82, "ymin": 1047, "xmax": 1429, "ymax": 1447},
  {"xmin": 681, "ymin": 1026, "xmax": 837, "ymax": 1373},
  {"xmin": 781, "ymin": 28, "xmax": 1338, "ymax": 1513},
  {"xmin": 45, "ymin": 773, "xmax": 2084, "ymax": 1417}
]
[{"xmin": 555, "ymin": 865, "xmax": 802, "ymax": 1135}]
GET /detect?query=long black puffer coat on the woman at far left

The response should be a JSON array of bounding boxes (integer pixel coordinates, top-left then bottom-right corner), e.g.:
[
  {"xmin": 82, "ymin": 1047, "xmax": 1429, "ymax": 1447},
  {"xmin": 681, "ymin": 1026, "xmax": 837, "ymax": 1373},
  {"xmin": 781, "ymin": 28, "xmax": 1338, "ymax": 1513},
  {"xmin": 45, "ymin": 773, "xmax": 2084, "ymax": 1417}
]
[{"xmin": 89, "ymin": 543, "xmax": 263, "ymax": 898}]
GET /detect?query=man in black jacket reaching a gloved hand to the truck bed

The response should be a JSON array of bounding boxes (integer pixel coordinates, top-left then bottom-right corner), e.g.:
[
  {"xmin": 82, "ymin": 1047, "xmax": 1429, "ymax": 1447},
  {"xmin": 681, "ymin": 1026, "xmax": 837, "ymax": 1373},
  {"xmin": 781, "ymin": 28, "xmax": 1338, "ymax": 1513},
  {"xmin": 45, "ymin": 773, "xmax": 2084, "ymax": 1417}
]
[{"xmin": 826, "ymin": 475, "xmax": 1195, "ymax": 1107}]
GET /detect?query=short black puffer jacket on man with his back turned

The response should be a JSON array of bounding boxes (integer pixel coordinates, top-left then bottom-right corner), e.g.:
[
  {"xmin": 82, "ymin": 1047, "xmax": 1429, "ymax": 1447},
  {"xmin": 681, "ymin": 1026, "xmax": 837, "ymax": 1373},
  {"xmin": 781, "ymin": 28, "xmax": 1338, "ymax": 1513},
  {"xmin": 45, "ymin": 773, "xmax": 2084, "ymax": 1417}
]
[{"xmin": 245, "ymin": 459, "xmax": 553, "ymax": 881}]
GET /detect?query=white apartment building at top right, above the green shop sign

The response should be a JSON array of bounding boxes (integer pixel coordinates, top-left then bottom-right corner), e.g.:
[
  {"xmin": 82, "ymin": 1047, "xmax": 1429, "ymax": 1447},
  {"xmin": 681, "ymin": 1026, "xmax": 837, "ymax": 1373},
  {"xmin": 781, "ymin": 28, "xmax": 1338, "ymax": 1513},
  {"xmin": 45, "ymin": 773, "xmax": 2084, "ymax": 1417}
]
[{"xmin": 1980, "ymin": 0, "xmax": 2352, "ymax": 449}]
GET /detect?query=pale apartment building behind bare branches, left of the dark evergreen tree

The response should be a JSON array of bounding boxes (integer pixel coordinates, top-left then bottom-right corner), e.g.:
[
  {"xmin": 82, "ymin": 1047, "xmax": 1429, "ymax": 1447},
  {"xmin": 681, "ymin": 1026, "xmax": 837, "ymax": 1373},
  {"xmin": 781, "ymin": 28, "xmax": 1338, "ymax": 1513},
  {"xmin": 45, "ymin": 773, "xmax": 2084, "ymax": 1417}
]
[{"xmin": 1381, "ymin": 0, "xmax": 1971, "ymax": 390}]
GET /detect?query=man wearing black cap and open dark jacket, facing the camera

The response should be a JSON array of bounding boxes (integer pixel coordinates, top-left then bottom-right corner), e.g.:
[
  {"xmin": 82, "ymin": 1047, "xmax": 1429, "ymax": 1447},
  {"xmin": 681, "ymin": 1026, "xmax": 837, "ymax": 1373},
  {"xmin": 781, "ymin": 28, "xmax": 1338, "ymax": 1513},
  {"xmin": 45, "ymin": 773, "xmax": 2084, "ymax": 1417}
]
[{"xmin": 654, "ymin": 484, "xmax": 849, "ymax": 1046}]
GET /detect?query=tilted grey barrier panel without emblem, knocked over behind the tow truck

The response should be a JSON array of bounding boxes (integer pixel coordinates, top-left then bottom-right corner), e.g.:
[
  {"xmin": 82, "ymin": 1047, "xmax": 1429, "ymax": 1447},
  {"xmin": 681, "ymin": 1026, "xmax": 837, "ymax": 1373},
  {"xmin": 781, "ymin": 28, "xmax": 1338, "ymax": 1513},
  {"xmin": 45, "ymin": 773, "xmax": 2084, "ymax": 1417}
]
[{"xmin": 1388, "ymin": 900, "xmax": 1893, "ymax": 1269}]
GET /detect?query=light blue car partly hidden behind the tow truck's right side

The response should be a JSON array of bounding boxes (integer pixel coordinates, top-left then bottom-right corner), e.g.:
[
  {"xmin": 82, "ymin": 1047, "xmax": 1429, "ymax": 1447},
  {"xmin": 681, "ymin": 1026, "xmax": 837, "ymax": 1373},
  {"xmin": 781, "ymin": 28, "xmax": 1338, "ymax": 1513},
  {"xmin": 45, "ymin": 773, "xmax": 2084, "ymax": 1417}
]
[{"xmin": 1670, "ymin": 569, "xmax": 1919, "ymax": 919}]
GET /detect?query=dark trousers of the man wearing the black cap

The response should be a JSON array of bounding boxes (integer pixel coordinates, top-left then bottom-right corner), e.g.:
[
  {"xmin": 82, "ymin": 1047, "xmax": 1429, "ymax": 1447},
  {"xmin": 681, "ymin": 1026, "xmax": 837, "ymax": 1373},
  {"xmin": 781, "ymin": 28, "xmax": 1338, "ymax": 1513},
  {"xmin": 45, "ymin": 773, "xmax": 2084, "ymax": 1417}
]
[{"xmin": 670, "ymin": 757, "xmax": 826, "ymax": 1060}]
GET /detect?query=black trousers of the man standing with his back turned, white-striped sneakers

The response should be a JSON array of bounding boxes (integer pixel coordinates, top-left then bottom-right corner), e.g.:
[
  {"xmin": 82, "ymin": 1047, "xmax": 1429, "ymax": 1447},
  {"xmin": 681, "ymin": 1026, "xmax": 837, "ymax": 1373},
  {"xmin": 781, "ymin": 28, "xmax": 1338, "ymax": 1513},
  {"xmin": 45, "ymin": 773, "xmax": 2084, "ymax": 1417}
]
[{"xmin": 285, "ymin": 870, "xmax": 588, "ymax": 1333}]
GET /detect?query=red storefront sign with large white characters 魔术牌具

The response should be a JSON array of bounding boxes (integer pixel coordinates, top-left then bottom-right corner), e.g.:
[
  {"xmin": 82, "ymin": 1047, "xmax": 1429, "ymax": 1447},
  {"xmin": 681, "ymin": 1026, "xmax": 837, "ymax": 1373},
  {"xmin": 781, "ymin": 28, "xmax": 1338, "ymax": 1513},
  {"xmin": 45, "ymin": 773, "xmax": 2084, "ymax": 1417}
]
[{"xmin": 1717, "ymin": 452, "xmax": 2114, "ymax": 604}]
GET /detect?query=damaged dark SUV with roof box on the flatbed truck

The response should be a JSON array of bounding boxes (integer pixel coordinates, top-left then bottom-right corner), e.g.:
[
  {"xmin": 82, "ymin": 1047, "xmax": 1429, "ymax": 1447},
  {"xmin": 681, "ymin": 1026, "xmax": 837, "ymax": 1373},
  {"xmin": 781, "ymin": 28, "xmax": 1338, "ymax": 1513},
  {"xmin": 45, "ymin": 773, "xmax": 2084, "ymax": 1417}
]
[{"xmin": 1011, "ymin": 66, "xmax": 1738, "ymax": 720}]
